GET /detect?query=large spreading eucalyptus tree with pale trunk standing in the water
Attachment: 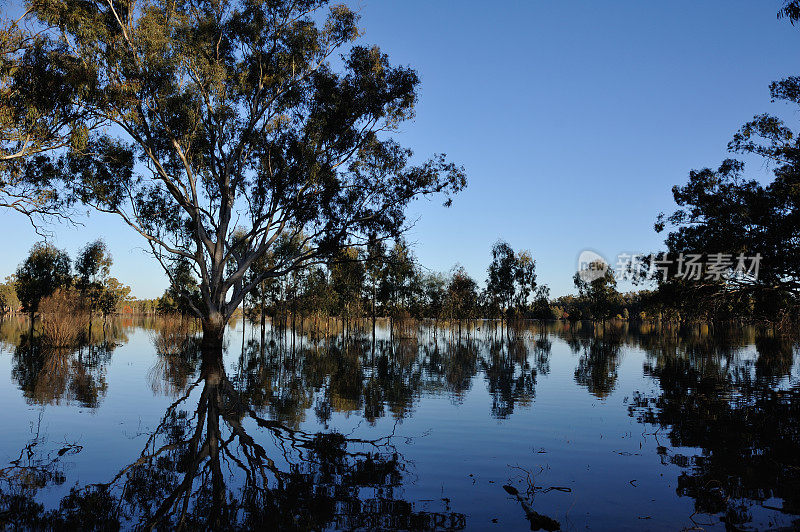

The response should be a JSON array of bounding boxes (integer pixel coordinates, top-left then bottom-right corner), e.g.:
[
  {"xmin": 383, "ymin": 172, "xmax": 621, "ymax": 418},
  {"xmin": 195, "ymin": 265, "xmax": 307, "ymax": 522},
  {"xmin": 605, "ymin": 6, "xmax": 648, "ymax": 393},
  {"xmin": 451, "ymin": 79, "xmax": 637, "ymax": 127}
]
[{"xmin": 12, "ymin": 0, "xmax": 465, "ymax": 342}]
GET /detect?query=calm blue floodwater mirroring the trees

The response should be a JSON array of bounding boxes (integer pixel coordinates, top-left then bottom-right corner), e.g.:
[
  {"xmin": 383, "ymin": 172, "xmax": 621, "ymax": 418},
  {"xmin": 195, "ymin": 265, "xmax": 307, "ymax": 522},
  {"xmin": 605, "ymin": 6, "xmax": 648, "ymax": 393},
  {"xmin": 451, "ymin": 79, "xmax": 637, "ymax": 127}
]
[{"xmin": 0, "ymin": 319, "xmax": 800, "ymax": 530}]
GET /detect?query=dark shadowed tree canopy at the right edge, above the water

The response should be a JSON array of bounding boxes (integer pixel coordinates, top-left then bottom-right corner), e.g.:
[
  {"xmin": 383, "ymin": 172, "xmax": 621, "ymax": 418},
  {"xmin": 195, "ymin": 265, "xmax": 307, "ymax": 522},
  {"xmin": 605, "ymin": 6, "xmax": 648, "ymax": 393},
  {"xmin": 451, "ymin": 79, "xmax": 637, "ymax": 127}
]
[{"xmin": 656, "ymin": 77, "xmax": 800, "ymax": 317}]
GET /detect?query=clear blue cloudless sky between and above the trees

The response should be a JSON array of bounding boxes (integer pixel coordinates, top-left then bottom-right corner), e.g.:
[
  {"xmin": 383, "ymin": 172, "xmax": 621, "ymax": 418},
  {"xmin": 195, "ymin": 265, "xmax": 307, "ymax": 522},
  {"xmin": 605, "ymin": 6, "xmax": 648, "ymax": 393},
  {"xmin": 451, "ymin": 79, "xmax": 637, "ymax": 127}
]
[{"xmin": 0, "ymin": 0, "xmax": 800, "ymax": 297}]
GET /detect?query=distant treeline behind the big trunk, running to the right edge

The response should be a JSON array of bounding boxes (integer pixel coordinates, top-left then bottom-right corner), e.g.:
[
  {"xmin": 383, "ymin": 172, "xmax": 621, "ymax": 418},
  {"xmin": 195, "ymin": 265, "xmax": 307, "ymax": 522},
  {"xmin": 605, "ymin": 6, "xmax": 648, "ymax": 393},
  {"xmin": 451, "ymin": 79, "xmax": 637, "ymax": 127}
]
[{"xmin": 148, "ymin": 240, "xmax": 795, "ymax": 328}]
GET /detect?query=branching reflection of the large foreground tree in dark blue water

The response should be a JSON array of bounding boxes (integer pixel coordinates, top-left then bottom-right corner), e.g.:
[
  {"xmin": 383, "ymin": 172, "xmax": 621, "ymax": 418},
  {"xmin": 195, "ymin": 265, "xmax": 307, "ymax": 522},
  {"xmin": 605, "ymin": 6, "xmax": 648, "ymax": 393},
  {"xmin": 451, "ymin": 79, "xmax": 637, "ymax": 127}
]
[{"xmin": 0, "ymin": 354, "xmax": 466, "ymax": 530}]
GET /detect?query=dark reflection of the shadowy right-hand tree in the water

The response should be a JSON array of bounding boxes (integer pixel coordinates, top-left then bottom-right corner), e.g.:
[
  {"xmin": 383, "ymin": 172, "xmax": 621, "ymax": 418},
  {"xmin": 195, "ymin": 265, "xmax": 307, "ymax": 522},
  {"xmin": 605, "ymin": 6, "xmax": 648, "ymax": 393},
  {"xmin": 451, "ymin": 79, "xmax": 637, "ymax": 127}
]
[{"xmin": 630, "ymin": 330, "xmax": 800, "ymax": 529}]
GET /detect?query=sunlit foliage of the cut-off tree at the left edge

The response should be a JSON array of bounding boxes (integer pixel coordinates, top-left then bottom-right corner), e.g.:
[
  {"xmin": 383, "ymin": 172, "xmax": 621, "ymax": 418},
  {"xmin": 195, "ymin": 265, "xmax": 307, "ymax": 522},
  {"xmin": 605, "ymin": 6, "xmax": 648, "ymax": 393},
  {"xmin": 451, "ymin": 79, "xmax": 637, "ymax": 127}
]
[{"xmin": 0, "ymin": 13, "xmax": 93, "ymax": 223}]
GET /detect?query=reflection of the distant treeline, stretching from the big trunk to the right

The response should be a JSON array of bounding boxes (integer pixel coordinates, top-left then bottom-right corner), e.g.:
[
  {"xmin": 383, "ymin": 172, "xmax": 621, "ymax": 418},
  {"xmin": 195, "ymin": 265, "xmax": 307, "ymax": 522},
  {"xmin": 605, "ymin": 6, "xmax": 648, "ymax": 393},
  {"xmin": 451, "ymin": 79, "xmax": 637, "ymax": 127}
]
[{"xmin": 144, "ymin": 321, "xmax": 790, "ymax": 426}]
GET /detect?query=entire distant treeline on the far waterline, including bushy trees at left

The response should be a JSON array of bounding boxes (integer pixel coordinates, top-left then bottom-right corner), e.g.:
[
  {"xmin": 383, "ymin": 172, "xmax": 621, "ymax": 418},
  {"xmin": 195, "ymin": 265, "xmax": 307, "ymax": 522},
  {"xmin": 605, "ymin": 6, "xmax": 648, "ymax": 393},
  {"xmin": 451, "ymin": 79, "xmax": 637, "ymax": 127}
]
[{"xmin": 0, "ymin": 231, "xmax": 797, "ymax": 330}]
